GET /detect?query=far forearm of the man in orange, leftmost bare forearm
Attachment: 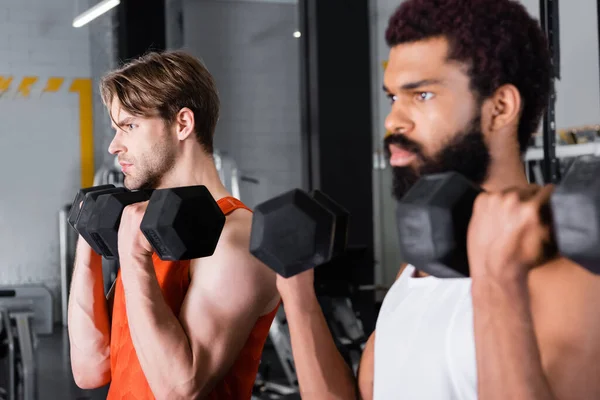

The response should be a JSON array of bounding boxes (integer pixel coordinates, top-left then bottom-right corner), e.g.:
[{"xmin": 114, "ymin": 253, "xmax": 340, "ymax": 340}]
[{"xmin": 68, "ymin": 238, "xmax": 111, "ymax": 389}]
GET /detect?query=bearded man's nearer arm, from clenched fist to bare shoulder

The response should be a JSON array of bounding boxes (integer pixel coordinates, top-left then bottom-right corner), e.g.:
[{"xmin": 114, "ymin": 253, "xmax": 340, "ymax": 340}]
[{"xmin": 469, "ymin": 187, "xmax": 600, "ymax": 400}]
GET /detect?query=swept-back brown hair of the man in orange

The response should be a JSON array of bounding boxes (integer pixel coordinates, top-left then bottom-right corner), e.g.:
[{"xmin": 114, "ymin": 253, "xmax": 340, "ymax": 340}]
[{"xmin": 100, "ymin": 51, "xmax": 220, "ymax": 154}]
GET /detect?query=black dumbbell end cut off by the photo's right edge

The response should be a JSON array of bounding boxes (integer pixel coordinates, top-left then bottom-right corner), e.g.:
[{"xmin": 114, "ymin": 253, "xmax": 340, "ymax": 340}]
[{"xmin": 550, "ymin": 156, "xmax": 600, "ymax": 274}]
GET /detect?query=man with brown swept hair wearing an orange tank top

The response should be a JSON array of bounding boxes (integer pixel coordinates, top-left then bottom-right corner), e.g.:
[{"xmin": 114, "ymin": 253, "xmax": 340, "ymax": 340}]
[{"xmin": 68, "ymin": 51, "xmax": 279, "ymax": 400}]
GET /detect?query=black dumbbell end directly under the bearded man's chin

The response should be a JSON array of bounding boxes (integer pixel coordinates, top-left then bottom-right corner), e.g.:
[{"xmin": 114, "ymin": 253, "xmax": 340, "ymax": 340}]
[{"xmin": 396, "ymin": 172, "xmax": 481, "ymax": 278}]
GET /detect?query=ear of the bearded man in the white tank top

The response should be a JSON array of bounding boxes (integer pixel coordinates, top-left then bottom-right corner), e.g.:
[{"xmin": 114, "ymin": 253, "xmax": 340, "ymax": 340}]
[{"xmin": 489, "ymin": 84, "xmax": 522, "ymax": 131}]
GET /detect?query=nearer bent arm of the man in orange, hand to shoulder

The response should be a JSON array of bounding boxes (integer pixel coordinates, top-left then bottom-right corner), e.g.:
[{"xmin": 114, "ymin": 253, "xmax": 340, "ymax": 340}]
[{"xmin": 119, "ymin": 203, "xmax": 279, "ymax": 399}]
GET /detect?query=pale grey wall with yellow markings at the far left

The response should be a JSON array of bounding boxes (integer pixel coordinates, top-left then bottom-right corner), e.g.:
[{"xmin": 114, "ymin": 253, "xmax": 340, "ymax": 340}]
[{"xmin": 0, "ymin": 0, "xmax": 93, "ymax": 320}]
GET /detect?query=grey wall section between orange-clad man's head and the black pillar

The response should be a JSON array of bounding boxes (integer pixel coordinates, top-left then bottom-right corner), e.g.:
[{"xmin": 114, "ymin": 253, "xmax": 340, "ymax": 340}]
[{"xmin": 177, "ymin": 0, "xmax": 302, "ymax": 207}]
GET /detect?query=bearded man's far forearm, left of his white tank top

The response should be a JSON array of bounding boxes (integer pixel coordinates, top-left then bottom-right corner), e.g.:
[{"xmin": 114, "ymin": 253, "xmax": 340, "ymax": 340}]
[{"xmin": 283, "ymin": 293, "xmax": 357, "ymax": 400}]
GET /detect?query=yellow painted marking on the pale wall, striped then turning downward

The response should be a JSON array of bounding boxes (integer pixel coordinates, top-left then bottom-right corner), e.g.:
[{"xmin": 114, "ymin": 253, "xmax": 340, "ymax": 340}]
[{"xmin": 0, "ymin": 75, "xmax": 94, "ymax": 187}]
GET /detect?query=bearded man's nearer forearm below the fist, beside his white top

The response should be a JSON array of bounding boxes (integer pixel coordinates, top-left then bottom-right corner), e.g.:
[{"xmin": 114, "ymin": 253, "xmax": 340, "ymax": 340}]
[{"xmin": 472, "ymin": 278, "xmax": 555, "ymax": 400}]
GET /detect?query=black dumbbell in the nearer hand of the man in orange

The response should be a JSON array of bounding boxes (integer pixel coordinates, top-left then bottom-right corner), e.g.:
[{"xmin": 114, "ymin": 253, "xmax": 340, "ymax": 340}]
[{"xmin": 84, "ymin": 186, "xmax": 225, "ymax": 261}]
